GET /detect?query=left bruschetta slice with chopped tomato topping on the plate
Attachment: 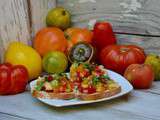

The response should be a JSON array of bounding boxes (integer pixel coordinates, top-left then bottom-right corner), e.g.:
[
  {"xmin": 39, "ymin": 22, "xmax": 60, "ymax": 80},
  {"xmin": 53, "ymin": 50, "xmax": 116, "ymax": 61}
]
[{"xmin": 32, "ymin": 73, "xmax": 75, "ymax": 99}]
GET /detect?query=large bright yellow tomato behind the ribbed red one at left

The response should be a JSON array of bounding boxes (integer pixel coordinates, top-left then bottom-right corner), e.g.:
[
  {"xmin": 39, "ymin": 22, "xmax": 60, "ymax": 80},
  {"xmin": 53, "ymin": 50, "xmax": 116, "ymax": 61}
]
[{"xmin": 5, "ymin": 42, "xmax": 42, "ymax": 80}]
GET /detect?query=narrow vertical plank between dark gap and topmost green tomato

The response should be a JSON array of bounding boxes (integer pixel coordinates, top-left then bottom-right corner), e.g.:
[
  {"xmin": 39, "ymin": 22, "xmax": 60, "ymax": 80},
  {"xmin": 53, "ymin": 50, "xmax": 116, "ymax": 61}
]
[{"xmin": 29, "ymin": 0, "xmax": 56, "ymax": 35}]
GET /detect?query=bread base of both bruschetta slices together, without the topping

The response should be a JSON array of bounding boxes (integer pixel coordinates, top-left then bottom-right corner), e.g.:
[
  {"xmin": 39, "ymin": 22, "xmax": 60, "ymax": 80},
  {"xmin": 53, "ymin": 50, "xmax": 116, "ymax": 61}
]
[{"xmin": 32, "ymin": 84, "xmax": 121, "ymax": 100}]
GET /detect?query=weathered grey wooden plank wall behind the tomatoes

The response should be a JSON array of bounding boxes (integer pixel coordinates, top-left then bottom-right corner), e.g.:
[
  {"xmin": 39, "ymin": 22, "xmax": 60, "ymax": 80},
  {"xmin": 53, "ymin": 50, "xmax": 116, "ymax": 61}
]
[{"xmin": 0, "ymin": 0, "xmax": 160, "ymax": 61}]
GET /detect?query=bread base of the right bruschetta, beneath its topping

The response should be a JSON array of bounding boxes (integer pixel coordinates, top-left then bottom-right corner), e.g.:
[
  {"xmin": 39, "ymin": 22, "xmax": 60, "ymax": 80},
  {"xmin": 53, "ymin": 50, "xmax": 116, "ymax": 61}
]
[{"xmin": 76, "ymin": 84, "xmax": 121, "ymax": 100}]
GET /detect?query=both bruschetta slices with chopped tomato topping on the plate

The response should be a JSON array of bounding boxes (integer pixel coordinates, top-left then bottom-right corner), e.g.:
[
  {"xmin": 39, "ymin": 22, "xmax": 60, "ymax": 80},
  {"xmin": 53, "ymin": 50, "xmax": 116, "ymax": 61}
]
[{"xmin": 32, "ymin": 63, "xmax": 121, "ymax": 100}]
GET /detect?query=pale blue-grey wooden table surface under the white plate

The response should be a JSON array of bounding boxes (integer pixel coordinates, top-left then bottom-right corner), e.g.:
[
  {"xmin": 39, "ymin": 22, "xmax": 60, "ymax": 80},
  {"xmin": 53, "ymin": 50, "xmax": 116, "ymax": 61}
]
[{"xmin": 0, "ymin": 82, "xmax": 160, "ymax": 120}]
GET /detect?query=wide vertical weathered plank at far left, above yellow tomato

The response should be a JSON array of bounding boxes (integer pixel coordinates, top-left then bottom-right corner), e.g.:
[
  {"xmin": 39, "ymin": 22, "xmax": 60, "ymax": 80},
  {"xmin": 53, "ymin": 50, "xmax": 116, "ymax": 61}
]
[{"xmin": 0, "ymin": 0, "xmax": 30, "ymax": 60}]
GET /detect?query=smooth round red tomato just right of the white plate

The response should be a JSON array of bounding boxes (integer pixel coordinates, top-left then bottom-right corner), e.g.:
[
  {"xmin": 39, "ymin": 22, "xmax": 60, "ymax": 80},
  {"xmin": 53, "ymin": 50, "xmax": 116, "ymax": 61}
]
[{"xmin": 124, "ymin": 64, "xmax": 154, "ymax": 89}]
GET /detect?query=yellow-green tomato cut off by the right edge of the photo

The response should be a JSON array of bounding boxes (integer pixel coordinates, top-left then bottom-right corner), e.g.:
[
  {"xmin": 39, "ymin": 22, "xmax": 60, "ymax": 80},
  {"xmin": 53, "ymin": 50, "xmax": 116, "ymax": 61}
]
[{"xmin": 145, "ymin": 54, "xmax": 160, "ymax": 80}]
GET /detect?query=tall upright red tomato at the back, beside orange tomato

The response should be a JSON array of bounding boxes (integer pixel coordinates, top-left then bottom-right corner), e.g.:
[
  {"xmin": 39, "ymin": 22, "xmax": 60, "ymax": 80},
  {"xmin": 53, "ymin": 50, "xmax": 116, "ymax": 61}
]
[{"xmin": 93, "ymin": 22, "xmax": 116, "ymax": 50}]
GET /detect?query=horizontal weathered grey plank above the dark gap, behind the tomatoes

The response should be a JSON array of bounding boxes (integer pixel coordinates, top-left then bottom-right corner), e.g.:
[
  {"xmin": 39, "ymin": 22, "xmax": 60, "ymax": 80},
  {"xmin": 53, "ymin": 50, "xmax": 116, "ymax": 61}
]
[{"xmin": 58, "ymin": 0, "xmax": 160, "ymax": 36}]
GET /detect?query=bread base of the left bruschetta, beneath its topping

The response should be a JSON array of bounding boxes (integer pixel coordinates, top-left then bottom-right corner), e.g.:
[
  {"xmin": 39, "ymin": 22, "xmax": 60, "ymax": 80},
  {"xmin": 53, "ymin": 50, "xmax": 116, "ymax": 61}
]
[{"xmin": 32, "ymin": 90, "xmax": 75, "ymax": 100}]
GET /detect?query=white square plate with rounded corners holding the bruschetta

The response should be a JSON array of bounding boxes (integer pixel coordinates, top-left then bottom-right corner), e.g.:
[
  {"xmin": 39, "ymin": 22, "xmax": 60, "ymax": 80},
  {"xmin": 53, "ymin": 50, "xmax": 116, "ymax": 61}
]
[{"xmin": 30, "ymin": 70, "xmax": 133, "ymax": 107}]
